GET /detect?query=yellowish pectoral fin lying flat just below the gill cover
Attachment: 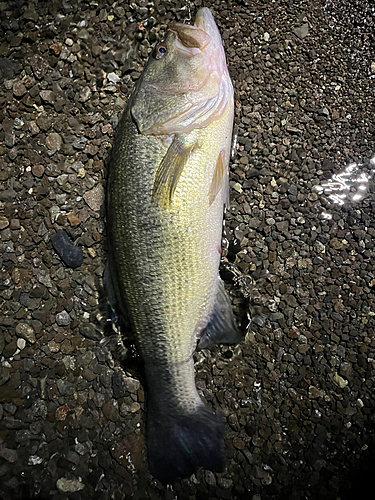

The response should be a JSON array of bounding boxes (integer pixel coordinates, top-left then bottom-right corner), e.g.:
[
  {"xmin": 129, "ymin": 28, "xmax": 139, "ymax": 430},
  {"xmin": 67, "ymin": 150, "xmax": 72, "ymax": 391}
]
[{"xmin": 152, "ymin": 136, "xmax": 193, "ymax": 206}]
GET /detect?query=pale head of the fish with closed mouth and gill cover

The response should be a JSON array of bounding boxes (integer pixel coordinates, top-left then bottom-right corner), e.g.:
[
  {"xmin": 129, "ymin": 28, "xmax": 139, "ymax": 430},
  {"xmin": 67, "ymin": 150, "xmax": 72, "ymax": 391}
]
[{"xmin": 130, "ymin": 8, "xmax": 233, "ymax": 135}]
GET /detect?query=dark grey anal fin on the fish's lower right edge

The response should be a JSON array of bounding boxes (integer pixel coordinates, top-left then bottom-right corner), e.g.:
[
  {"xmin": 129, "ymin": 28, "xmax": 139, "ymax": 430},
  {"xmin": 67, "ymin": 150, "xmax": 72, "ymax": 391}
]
[{"xmin": 198, "ymin": 278, "xmax": 242, "ymax": 349}]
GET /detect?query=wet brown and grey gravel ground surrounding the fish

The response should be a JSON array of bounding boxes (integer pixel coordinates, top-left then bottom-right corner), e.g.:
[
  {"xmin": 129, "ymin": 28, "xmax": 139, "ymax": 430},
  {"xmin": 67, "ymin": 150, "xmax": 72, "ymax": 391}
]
[{"xmin": 0, "ymin": 0, "xmax": 375, "ymax": 500}]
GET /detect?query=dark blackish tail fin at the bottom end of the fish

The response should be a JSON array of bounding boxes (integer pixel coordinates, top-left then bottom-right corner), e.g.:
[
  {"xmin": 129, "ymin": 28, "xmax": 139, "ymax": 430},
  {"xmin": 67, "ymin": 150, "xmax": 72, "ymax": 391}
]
[{"xmin": 147, "ymin": 403, "xmax": 224, "ymax": 484}]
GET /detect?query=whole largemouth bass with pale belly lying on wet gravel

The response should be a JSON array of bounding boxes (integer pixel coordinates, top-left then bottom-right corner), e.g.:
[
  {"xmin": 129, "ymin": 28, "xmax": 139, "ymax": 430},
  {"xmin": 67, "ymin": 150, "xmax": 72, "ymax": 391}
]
[{"xmin": 105, "ymin": 8, "xmax": 241, "ymax": 484}]
